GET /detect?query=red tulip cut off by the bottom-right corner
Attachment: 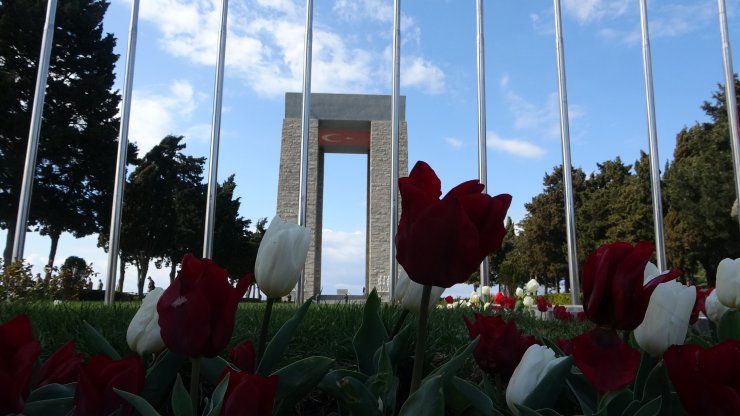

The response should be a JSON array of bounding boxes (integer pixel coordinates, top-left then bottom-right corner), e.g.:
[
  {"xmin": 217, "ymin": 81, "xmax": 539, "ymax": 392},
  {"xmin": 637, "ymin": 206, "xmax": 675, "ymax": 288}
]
[{"xmin": 663, "ymin": 340, "xmax": 740, "ymax": 416}]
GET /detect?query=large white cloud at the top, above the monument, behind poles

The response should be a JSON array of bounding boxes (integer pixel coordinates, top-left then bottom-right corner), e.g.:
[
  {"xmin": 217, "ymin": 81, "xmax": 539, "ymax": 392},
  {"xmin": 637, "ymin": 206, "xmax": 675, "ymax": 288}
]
[{"xmin": 129, "ymin": 0, "xmax": 445, "ymax": 97}]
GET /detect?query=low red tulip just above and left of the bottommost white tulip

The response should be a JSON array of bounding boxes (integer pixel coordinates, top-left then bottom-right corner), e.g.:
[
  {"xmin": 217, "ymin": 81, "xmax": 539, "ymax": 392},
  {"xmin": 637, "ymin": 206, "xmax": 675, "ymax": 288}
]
[{"xmin": 463, "ymin": 313, "xmax": 537, "ymax": 382}]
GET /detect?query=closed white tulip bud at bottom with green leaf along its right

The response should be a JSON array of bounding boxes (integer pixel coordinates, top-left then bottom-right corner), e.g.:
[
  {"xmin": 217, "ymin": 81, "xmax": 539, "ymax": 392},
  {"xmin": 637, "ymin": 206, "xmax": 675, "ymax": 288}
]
[{"xmin": 506, "ymin": 344, "xmax": 571, "ymax": 415}]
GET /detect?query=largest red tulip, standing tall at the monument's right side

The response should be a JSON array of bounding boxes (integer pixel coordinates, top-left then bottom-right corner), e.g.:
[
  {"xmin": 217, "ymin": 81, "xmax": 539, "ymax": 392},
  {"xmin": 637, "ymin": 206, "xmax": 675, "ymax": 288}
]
[{"xmin": 396, "ymin": 162, "xmax": 511, "ymax": 287}]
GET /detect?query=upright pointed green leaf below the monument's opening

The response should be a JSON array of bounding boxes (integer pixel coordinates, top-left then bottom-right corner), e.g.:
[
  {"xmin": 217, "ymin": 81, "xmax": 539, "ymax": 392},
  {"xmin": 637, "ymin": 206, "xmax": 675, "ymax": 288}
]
[{"xmin": 352, "ymin": 289, "xmax": 388, "ymax": 375}]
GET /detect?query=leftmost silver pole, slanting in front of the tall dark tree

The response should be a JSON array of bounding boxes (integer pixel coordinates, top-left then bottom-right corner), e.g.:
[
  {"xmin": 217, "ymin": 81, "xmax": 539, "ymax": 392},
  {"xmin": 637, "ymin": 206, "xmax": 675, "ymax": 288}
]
[{"xmin": 13, "ymin": 0, "xmax": 57, "ymax": 261}]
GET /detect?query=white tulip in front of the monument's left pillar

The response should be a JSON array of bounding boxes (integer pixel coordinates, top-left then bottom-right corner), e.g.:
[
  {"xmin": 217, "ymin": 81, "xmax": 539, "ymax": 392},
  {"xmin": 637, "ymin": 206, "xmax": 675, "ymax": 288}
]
[{"xmin": 254, "ymin": 215, "xmax": 311, "ymax": 299}]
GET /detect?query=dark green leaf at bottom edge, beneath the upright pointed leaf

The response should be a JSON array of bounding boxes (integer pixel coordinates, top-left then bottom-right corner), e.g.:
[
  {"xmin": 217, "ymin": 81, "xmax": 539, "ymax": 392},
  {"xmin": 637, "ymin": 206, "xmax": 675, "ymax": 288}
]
[{"xmin": 319, "ymin": 371, "xmax": 381, "ymax": 416}]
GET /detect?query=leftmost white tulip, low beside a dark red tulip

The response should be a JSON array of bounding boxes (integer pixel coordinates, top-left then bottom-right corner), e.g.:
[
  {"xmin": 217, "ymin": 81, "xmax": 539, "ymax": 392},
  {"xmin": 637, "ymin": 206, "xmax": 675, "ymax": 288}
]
[{"xmin": 126, "ymin": 287, "xmax": 164, "ymax": 355}]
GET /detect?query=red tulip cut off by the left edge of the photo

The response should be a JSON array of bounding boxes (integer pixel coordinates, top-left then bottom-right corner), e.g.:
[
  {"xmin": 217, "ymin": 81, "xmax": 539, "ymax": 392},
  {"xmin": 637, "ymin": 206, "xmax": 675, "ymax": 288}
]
[{"xmin": 0, "ymin": 315, "xmax": 41, "ymax": 415}]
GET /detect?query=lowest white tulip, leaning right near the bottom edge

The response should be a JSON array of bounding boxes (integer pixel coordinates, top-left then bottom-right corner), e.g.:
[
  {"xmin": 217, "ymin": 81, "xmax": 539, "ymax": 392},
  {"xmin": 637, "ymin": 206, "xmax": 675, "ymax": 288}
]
[{"xmin": 506, "ymin": 344, "xmax": 569, "ymax": 415}]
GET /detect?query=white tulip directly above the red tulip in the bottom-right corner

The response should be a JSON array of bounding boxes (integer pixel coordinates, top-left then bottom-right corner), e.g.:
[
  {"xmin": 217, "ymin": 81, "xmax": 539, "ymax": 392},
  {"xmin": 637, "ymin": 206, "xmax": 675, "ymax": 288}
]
[{"xmin": 634, "ymin": 280, "xmax": 696, "ymax": 357}]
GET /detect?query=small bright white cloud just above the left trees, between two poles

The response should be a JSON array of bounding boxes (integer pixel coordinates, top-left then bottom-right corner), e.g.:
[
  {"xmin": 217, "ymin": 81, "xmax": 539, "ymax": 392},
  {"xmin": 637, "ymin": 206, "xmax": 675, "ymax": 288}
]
[{"xmin": 129, "ymin": 81, "xmax": 198, "ymax": 153}]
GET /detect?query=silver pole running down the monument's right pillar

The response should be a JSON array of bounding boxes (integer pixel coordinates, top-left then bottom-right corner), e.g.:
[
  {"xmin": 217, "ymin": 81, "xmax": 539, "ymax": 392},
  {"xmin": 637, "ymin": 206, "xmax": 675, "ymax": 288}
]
[{"xmin": 388, "ymin": 0, "xmax": 401, "ymax": 301}]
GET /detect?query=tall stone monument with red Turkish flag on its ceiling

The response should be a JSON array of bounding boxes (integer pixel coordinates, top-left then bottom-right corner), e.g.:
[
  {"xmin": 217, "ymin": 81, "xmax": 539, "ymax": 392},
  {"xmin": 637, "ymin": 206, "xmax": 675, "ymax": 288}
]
[{"xmin": 277, "ymin": 93, "xmax": 408, "ymax": 301}]
